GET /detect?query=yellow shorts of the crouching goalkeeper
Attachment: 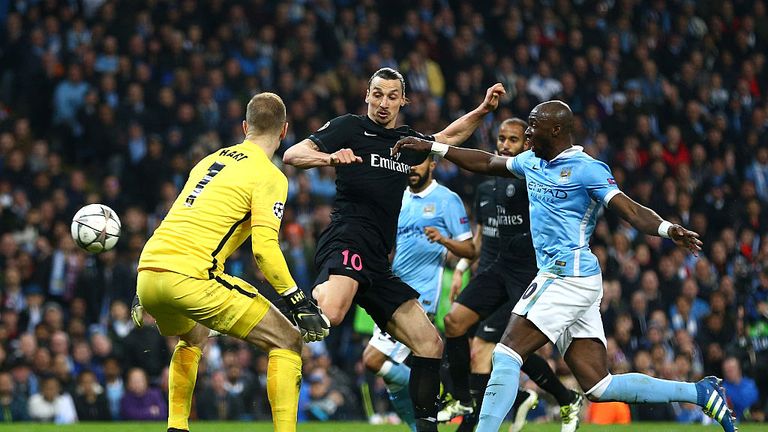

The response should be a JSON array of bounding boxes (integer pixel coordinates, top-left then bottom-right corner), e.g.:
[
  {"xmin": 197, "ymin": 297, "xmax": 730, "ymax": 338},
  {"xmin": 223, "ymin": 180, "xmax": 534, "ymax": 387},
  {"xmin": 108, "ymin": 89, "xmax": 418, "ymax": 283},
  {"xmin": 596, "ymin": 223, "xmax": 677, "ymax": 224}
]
[{"xmin": 136, "ymin": 269, "xmax": 272, "ymax": 339}]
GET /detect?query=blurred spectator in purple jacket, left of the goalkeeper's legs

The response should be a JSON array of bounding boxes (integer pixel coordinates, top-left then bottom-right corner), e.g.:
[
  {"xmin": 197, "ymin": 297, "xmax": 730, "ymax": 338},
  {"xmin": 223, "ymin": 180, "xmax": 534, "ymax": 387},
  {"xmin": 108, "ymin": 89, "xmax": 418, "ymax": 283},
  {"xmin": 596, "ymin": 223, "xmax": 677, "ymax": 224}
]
[{"xmin": 120, "ymin": 368, "xmax": 168, "ymax": 421}]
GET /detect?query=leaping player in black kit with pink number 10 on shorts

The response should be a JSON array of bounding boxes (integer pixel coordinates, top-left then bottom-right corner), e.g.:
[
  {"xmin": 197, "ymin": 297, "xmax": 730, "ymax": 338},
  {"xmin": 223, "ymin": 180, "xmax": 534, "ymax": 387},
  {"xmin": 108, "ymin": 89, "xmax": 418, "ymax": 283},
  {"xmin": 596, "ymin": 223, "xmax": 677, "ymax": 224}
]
[{"xmin": 283, "ymin": 68, "xmax": 506, "ymax": 432}]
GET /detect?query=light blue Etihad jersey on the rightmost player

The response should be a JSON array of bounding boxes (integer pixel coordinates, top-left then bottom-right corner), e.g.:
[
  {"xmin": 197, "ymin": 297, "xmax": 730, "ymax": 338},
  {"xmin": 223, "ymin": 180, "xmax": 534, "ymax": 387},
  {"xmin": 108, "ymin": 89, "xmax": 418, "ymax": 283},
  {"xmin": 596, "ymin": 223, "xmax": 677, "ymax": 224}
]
[{"xmin": 507, "ymin": 146, "xmax": 620, "ymax": 276}]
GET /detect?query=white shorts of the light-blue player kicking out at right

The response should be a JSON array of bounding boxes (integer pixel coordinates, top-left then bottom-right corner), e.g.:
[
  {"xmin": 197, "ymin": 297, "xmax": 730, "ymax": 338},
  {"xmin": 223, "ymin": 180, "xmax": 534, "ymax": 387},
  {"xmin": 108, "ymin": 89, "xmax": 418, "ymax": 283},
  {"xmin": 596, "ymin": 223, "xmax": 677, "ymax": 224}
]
[{"xmin": 512, "ymin": 273, "xmax": 606, "ymax": 354}]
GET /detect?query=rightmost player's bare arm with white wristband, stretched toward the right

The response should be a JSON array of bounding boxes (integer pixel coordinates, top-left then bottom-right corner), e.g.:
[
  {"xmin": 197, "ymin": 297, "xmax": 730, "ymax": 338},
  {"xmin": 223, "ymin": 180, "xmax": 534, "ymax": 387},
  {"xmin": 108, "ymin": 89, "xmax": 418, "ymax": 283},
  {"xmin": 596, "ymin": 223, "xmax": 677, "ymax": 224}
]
[{"xmin": 608, "ymin": 193, "xmax": 703, "ymax": 255}]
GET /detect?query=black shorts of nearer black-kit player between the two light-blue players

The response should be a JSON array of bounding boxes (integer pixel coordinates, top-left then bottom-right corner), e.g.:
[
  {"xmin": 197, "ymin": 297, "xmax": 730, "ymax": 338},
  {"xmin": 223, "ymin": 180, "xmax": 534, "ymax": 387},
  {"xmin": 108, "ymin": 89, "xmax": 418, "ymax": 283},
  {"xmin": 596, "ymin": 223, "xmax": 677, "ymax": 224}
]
[{"xmin": 456, "ymin": 259, "xmax": 538, "ymax": 334}]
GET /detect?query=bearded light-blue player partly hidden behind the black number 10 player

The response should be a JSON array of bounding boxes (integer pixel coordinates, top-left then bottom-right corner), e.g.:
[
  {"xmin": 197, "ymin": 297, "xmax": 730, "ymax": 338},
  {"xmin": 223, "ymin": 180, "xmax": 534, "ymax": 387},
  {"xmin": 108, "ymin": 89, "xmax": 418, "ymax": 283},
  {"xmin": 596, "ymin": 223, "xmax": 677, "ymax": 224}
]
[{"xmin": 363, "ymin": 157, "xmax": 475, "ymax": 431}]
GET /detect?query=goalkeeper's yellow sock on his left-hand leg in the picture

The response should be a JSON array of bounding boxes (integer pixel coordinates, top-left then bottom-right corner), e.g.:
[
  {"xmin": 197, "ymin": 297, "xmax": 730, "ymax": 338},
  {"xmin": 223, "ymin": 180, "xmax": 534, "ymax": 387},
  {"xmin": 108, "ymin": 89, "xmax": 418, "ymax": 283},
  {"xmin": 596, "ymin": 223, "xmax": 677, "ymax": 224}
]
[{"xmin": 168, "ymin": 340, "xmax": 203, "ymax": 430}]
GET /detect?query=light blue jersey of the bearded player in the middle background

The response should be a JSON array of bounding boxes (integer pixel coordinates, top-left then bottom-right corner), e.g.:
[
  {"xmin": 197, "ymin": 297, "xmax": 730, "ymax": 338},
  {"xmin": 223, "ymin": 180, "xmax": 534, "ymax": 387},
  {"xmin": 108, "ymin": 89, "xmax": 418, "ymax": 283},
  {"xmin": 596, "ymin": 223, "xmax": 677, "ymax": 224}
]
[{"xmin": 392, "ymin": 180, "xmax": 472, "ymax": 313}]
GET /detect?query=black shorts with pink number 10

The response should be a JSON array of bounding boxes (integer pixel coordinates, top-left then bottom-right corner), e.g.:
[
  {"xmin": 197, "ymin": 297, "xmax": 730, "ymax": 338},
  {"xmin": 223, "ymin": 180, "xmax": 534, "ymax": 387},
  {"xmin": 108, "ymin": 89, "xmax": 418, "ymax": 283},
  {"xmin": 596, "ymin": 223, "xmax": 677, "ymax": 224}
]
[{"xmin": 315, "ymin": 226, "xmax": 419, "ymax": 330}]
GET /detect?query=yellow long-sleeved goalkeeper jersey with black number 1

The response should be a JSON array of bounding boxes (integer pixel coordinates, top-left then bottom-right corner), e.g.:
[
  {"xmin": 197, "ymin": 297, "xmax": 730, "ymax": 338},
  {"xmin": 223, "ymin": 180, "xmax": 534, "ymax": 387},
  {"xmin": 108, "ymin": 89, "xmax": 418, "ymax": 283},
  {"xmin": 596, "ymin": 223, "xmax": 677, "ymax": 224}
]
[{"xmin": 139, "ymin": 140, "xmax": 296, "ymax": 292}]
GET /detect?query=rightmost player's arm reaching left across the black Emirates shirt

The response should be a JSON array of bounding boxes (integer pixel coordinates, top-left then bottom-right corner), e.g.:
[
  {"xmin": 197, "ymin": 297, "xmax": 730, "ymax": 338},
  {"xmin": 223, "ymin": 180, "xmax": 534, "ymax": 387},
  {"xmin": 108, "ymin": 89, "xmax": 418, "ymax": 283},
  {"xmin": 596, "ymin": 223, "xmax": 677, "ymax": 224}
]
[{"xmin": 392, "ymin": 137, "xmax": 515, "ymax": 177}]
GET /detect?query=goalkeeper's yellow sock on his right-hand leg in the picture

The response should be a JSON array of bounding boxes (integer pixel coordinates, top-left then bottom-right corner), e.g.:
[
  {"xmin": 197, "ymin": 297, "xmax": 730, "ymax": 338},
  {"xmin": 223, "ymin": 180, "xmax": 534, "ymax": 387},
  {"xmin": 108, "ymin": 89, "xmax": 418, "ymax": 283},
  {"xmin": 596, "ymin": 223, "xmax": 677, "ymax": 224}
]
[{"xmin": 267, "ymin": 349, "xmax": 301, "ymax": 432}]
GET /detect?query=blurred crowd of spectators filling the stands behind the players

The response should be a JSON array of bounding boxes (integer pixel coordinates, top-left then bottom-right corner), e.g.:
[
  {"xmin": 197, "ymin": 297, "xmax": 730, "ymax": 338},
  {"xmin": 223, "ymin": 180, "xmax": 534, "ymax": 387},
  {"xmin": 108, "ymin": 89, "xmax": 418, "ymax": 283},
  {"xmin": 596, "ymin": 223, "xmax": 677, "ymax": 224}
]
[{"xmin": 0, "ymin": 0, "xmax": 768, "ymax": 423}]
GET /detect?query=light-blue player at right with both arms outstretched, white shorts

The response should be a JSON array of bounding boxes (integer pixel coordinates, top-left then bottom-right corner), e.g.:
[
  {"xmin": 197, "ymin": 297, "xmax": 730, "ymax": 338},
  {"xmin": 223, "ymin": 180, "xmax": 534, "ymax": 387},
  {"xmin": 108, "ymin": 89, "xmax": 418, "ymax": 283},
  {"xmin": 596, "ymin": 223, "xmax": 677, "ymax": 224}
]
[{"xmin": 393, "ymin": 101, "xmax": 737, "ymax": 432}]
